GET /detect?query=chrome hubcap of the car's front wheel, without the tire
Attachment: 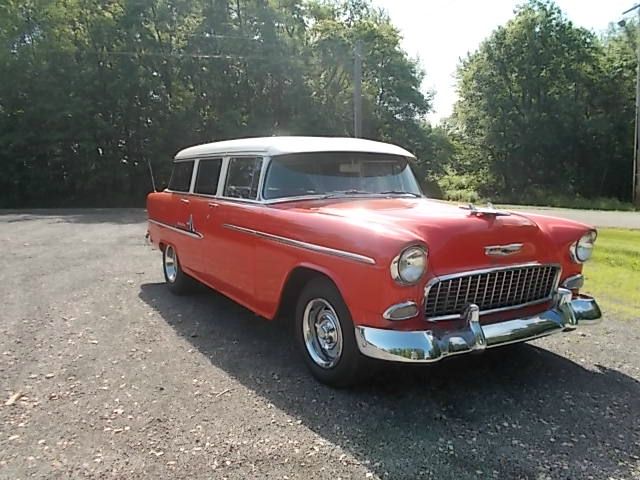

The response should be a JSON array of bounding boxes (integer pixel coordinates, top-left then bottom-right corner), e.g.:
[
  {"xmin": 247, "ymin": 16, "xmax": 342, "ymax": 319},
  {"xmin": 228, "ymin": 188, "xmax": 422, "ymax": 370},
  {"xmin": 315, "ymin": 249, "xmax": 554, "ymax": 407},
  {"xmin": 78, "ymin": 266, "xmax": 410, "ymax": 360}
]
[{"xmin": 302, "ymin": 298, "xmax": 342, "ymax": 368}]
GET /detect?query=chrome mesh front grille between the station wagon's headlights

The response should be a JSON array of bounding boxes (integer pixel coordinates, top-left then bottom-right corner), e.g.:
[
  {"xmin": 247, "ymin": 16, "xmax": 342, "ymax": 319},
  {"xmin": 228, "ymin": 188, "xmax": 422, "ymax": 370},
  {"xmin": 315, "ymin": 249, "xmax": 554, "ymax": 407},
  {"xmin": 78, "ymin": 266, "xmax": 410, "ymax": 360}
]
[{"xmin": 425, "ymin": 264, "xmax": 560, "ymax": 320}]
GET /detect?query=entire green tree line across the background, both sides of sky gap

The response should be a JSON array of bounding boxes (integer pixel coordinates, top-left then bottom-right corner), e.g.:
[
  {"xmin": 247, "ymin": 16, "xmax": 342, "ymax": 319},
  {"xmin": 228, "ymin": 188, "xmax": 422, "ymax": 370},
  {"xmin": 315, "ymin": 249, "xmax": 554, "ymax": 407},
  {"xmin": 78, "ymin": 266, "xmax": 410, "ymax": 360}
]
[{"xmin": 0, "ymin": 0, "xmax": 637, "ymax": 207}]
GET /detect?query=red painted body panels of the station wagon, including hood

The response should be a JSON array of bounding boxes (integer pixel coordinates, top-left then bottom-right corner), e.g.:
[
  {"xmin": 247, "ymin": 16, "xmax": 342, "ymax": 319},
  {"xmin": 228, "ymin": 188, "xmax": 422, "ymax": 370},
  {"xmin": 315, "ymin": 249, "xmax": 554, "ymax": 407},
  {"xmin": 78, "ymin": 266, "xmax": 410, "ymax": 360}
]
[{"xmin": 147, "ymin": 192, "xmax": 591, "ymax": 329}]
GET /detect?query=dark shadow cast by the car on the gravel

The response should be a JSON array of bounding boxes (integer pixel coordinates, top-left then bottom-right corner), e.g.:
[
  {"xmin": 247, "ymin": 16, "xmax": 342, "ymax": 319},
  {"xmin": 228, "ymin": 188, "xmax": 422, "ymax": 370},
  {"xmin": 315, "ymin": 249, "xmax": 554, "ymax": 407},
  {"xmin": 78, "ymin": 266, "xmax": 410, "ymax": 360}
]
[{"xmin": 139, "ymin": 284, "xmax": 640, "ymax": 478}]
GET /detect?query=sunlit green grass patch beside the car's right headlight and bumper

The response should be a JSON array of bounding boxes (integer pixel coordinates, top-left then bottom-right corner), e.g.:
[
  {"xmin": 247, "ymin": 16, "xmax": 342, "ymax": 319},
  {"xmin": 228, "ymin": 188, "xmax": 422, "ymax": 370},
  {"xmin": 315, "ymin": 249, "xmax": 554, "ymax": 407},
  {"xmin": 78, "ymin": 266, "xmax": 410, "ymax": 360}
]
[{"xmin": 583, "ymin": 228, "xmax": 640, "ymax": 319}]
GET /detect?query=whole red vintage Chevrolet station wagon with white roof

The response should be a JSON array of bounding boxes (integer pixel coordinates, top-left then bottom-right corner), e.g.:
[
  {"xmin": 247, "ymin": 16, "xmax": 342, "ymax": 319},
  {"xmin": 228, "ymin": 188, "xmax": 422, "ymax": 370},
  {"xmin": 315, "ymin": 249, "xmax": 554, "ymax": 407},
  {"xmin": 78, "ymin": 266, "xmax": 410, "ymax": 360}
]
[{"xmin": 147, "ymin": 137, "xmax": 601, "ymax": 386}]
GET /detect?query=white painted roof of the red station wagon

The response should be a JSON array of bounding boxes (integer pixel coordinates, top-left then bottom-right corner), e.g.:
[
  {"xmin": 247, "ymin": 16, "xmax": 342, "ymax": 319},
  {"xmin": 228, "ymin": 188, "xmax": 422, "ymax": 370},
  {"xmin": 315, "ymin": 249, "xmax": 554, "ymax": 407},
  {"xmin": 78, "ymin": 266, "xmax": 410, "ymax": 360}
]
[{"xmin": 175, "ymin": 137, "xmax": 413, "ymax": 160}]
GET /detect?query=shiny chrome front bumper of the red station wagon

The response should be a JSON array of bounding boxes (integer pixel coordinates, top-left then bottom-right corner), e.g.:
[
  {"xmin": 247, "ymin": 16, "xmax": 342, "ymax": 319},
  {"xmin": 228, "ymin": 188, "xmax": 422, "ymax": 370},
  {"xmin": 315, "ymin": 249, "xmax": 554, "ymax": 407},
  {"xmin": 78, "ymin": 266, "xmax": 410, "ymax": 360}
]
[{"xmin": 356, "ymin": 288, "xmax": 602, "ymax": 363}]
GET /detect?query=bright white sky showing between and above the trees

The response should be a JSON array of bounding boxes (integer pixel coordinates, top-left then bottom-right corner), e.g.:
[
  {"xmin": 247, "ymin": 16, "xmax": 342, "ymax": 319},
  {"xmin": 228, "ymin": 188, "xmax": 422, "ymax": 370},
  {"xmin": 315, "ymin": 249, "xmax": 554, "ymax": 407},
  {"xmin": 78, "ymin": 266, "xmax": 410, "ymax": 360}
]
[{"xmin": 373, "ymin": 0, "xmax": 636, "ymax": 122}]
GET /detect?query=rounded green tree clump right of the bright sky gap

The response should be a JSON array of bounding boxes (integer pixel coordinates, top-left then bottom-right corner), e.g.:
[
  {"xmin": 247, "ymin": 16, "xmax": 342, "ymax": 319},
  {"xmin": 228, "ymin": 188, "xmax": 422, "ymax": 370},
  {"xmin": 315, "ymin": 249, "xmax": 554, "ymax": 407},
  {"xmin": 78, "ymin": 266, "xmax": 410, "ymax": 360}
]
[{"xmin": 452, "ymin": 0, "xmax": 636, "ymax": 200}]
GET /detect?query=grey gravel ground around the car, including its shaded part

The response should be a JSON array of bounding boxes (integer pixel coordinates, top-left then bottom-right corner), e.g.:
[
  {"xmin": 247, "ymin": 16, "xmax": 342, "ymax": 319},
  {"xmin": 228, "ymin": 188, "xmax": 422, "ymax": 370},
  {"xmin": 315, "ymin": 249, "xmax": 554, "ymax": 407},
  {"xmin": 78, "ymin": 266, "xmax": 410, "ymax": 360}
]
[{"xmin": 0, "ymin": 210, "xmax": 640, "ymax": 479}]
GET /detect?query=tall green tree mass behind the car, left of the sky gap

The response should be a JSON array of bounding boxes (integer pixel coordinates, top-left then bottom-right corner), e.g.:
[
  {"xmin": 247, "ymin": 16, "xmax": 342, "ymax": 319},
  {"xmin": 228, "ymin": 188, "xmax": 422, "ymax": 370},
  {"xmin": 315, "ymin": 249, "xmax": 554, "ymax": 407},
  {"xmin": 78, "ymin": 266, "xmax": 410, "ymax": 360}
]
[{"xmin": 0, "ymin": 0, "xmax": 432, "ymax": 207}]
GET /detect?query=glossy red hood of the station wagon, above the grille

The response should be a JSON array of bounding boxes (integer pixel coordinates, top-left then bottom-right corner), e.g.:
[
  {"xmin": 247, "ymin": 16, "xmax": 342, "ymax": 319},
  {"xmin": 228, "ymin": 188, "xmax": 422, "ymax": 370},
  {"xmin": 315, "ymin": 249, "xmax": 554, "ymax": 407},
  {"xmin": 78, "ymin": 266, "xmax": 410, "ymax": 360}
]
[{"xmin": 290, "ymin": 198, "xmax": 559, "ymax": 272}]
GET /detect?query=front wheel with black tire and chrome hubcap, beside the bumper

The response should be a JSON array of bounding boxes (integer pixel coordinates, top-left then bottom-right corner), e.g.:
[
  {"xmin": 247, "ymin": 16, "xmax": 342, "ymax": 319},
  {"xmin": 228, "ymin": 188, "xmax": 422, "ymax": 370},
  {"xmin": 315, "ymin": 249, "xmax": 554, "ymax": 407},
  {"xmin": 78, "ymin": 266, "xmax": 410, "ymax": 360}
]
[{"xmin": 295, "ymin": 278, "xmax": 366, "ymax": 387}]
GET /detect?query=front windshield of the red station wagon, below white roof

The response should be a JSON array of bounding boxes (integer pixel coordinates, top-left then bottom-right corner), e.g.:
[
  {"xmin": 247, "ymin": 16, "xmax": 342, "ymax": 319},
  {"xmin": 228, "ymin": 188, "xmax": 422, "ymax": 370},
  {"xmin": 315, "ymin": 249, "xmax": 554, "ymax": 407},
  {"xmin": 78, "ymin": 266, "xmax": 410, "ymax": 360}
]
[{"xmin": 263, "ymin": 152, "xmax": 422, "ymax": 199}]
